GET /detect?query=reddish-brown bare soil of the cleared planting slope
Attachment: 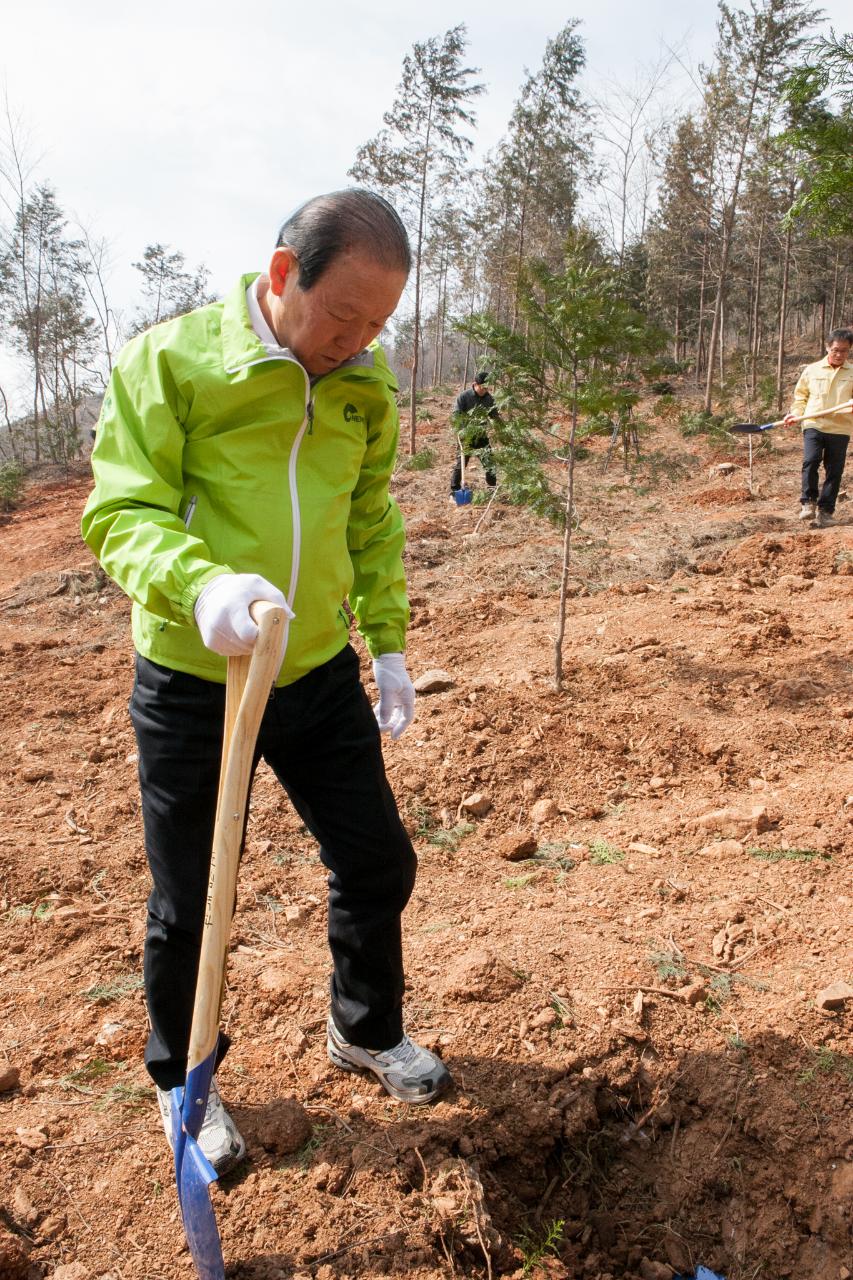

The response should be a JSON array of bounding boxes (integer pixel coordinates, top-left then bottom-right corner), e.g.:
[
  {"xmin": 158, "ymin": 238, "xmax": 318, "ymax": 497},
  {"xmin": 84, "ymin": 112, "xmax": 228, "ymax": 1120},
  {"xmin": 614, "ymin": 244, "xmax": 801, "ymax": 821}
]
[{"xmin": 0, "ymin": 402, "xmax": 853, "ymax": 1280}]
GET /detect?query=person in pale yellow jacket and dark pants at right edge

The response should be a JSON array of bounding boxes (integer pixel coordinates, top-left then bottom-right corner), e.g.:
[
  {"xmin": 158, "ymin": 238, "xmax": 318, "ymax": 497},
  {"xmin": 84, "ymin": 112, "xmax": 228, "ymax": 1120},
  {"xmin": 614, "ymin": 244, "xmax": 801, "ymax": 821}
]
[{"xmin": 785, "ymin": 329, "xmax": 853, "ymax": 529}]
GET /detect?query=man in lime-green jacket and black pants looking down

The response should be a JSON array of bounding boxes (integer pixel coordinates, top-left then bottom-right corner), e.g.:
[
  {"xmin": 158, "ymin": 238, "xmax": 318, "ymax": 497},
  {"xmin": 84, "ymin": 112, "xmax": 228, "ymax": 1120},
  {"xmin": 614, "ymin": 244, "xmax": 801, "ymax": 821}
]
[{"xmin": 82, "ymin": 189, "xmax": 450, "ymax": 1171}]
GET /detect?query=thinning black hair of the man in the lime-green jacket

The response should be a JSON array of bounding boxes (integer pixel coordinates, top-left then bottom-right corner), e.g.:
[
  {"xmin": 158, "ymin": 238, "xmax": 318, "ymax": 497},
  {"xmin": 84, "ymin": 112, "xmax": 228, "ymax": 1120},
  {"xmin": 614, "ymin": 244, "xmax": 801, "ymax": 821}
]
[{"xmin": 275, "ymin": 187, "xmax": 411, "ymax": 291}]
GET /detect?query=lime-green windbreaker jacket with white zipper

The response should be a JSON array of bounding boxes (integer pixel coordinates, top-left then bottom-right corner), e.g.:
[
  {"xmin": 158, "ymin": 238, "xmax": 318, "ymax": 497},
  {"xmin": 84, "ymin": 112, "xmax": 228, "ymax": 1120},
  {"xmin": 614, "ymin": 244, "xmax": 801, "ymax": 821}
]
[{"xmin": 82, "ymin": 275, "xmax": 409, "ymax": 685}]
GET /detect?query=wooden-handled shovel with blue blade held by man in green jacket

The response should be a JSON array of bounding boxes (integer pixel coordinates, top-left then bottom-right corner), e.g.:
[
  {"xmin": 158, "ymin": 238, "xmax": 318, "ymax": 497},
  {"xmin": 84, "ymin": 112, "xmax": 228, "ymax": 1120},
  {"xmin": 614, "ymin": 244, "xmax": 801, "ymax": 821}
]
[{"xmin": 170, "ymin": 600, "xmax": 286, "ymax": 1280}]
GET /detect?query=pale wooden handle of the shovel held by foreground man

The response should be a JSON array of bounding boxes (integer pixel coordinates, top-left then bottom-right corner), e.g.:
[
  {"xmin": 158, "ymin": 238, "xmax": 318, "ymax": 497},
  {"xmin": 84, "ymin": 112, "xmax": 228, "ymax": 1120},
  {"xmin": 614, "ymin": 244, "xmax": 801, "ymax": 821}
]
[{"xmin": 187, "ymin": 600, "xmax": 286, "ymax": 1071}]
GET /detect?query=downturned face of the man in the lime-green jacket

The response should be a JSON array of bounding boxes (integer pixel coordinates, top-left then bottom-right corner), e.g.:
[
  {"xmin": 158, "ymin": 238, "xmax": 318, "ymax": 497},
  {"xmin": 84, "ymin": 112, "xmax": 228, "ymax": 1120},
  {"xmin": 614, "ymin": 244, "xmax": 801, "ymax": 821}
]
[{"xmin": 268, "ymin": 248, "xmax": 406, "ymax": 376}]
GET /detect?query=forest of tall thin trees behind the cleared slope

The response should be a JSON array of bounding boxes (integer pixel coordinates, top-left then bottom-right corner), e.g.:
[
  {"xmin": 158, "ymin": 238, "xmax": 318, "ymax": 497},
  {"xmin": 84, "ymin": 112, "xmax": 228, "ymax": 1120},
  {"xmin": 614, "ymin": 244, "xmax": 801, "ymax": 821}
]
[{"xmin": 0, "ymin": 0, "xmax": 853, "ymax": 479}]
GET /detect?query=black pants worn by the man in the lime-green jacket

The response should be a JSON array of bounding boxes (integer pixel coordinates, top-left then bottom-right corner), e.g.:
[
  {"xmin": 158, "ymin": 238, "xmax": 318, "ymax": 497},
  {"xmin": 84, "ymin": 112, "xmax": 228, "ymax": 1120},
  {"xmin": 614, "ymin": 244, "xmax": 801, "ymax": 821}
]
[{"xmin": 131, "ymin": 645, "xmax": 415, "ymax": 1089}]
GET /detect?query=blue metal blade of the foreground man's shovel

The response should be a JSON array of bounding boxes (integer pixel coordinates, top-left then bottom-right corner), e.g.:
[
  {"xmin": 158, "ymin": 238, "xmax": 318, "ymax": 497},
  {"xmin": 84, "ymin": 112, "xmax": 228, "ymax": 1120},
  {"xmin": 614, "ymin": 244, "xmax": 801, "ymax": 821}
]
[{"xmin": 172, "ymin": 1047, "xmax": 225, "ymax": 1280}]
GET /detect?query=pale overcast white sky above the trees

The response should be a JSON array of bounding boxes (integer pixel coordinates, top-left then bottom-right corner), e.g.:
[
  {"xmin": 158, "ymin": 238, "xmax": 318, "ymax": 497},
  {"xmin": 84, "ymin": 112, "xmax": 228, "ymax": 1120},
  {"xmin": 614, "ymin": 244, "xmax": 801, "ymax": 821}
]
[{"xmin": 0, "ymin": 0, "xmax": 850, "ymax": 399}]
